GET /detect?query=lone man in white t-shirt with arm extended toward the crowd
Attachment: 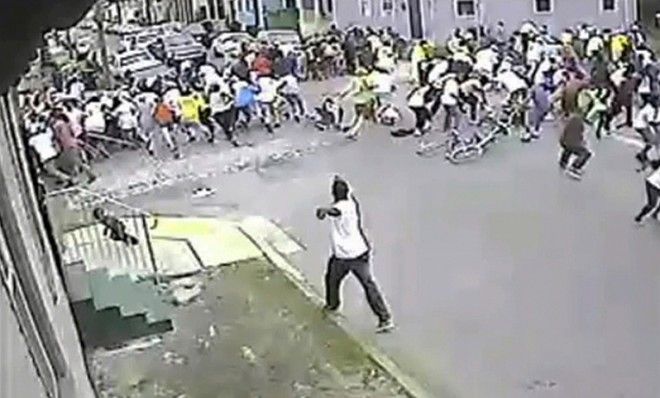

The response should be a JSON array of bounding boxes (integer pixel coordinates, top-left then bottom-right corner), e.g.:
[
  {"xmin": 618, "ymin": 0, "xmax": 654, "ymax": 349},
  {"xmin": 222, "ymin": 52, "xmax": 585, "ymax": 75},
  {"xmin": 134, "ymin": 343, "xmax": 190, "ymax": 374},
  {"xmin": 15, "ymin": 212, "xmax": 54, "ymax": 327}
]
[{"xmin": 316, "ymin": 176, "xmax": 394, "ymax": 333}]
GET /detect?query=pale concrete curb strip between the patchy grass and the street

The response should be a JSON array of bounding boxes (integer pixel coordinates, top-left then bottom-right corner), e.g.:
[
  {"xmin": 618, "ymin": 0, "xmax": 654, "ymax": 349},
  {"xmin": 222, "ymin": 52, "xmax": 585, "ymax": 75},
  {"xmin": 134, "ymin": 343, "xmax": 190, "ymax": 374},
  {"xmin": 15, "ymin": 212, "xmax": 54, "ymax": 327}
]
[{"xmin": 237, "ymin": 226, "xmax": 433, "ymax": 398}]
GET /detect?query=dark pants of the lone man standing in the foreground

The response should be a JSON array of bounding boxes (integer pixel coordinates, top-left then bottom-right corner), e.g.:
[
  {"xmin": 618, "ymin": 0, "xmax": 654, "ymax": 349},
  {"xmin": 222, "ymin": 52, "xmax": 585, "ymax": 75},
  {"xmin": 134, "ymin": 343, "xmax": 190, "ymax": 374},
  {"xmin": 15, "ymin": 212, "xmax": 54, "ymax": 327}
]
[{"xmin": 325, "ymin": 252, "xmax": 390, "ymax": 322}]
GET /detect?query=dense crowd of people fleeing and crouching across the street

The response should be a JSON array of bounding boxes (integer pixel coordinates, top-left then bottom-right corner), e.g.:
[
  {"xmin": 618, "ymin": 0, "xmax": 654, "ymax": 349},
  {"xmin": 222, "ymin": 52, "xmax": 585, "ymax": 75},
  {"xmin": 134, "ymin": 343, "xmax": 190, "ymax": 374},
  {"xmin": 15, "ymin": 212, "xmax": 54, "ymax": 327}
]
[{"xmin": 19, "ymin": 22, "xmax": 660, "ymax": 221}]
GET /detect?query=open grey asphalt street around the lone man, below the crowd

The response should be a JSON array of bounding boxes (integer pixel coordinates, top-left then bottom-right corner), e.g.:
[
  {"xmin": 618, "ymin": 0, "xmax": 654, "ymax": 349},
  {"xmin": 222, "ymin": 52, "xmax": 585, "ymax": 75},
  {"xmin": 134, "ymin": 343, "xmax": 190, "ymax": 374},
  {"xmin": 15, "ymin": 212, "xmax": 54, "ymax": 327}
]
[{"xmin": 90, "ymin": 76, "xmax": 660, "ymax": 398}]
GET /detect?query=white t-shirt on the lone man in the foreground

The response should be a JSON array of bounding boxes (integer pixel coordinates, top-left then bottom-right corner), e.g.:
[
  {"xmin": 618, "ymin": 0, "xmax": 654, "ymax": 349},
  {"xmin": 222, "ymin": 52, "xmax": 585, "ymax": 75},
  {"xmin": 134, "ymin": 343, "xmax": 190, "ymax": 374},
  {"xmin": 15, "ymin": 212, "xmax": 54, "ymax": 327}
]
[{"xmin": 330, "ymin": 196, "xmax": 369, "ymax": 260}]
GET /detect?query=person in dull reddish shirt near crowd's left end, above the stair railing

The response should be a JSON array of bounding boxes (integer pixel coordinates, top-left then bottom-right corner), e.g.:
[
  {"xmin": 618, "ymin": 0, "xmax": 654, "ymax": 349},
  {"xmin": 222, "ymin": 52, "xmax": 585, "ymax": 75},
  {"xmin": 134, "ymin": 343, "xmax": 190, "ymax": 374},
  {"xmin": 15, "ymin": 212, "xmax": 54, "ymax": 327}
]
[{"xmin": 52, "ymin": 111, "xmax": 96, "ymax": 183}]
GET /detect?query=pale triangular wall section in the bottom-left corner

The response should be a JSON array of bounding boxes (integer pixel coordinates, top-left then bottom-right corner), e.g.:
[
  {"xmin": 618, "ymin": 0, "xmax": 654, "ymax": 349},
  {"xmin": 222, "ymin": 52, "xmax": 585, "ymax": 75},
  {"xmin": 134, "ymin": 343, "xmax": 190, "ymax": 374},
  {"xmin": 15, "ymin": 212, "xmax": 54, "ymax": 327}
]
[{"xmin": 0, "ymin": 286, "xmax": 47, "ymax": 398}]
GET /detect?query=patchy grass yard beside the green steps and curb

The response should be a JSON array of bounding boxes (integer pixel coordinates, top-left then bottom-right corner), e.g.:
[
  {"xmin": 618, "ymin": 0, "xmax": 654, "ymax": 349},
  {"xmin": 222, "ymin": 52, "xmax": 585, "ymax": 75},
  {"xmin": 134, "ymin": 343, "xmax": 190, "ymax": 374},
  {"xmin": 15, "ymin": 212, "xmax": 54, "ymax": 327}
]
[{"xmin": 89, "ymin": 262, "xmax": 405, "ymax": 398}]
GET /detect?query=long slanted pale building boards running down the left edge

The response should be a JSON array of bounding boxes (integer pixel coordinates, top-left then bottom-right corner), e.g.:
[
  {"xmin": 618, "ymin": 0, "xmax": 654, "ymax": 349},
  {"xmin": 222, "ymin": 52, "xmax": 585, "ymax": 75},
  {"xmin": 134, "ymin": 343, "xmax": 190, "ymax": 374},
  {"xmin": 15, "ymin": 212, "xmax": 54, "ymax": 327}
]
[{"xmin": 0, "ymin": 91, "xmax": 94, "ymax": 398}]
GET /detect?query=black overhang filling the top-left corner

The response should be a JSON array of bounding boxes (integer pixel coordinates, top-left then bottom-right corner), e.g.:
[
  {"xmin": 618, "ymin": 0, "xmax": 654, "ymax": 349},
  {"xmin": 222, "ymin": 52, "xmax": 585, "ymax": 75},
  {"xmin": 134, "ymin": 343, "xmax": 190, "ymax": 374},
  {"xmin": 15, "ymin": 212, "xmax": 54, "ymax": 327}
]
[{"xmin": 0, "ymin": 0, "xmax": 94, "ymax": 93}]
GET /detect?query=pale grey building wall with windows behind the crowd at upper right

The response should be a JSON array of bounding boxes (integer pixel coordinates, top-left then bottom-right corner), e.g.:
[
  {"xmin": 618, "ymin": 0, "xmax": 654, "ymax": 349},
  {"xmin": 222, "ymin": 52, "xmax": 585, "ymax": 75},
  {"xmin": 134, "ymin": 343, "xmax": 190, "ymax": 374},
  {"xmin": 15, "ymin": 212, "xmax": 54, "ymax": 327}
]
[{"xmin": 335, "ymin": 0, "xmax": 636, "ymax": 40}]
